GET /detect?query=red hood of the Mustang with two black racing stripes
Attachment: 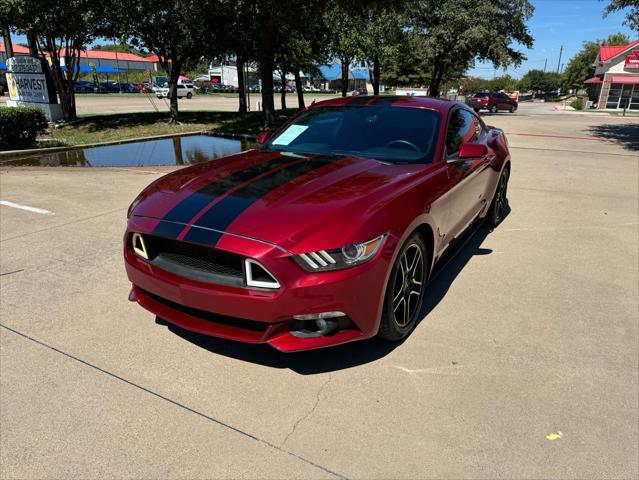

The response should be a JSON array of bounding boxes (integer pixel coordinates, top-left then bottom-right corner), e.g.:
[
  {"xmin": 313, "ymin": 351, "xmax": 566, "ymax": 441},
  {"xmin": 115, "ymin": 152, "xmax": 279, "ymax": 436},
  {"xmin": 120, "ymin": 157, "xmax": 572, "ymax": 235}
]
[{"xmin": 130, "ymin": 150, "xmax": 420, "ymax": 252}]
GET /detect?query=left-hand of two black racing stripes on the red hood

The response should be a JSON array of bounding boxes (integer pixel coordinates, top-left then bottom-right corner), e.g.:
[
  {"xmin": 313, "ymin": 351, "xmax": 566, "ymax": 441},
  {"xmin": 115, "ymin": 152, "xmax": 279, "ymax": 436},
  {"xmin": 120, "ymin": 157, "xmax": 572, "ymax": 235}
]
[{"xmin": 153, "ymin": 155, "xmax": 297, "ymax": 238}]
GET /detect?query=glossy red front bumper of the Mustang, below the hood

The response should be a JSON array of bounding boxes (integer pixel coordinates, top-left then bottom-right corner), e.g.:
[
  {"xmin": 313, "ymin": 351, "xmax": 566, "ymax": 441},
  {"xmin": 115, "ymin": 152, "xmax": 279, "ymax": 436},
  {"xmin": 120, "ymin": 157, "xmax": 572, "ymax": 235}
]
[{"xmin": 124, "ymin": 217, "xmax": 395, "ymax": 352}]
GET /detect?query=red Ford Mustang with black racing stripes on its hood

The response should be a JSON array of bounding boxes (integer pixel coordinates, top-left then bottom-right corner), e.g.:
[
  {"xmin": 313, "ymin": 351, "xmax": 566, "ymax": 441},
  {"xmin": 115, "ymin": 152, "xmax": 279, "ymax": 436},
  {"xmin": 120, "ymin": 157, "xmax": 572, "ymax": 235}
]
[{"xmin": 124, "ymin": 96, "xmax": 510, "ymax": 351}]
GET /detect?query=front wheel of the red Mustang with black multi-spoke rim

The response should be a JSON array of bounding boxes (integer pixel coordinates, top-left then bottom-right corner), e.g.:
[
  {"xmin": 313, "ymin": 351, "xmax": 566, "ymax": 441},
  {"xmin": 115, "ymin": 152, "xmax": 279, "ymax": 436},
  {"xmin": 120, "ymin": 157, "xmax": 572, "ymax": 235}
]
[{"xmin": 377, "ymin": 232, "xmax": 430, "ymax": 342}]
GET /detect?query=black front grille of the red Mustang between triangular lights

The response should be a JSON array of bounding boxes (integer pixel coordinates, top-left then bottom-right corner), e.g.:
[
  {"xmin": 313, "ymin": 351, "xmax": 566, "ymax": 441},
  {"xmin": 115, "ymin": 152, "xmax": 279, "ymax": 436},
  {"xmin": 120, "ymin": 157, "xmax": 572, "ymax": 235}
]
[{"xmin": 144, "ymin": 235, "xmax": 245, "ymax": 286}]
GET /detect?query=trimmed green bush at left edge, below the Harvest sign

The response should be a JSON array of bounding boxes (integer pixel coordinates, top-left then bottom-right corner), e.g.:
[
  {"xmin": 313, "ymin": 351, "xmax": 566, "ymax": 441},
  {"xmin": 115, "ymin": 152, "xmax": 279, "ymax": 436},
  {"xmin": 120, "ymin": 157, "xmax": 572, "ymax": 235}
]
[{"xmin": 0, "ymin": 107, "xmax": 48, "ymax": 150}]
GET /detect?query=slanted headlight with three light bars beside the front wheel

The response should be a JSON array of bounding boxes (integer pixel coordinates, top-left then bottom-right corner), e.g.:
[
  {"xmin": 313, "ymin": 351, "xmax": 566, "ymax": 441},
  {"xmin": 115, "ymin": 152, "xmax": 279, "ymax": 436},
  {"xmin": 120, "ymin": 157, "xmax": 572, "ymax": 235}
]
[{"xmin": 293, "ymin": 234, "xmax": 387, "ymax": 272}]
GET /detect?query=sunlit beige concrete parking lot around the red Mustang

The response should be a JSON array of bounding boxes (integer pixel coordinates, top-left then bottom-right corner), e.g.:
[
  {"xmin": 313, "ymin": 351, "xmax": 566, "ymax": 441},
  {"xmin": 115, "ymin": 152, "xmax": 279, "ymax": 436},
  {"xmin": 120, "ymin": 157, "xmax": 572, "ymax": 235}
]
[{"xmin": 0, "ymin": 102, "xmax": 639, "ymax": 479}]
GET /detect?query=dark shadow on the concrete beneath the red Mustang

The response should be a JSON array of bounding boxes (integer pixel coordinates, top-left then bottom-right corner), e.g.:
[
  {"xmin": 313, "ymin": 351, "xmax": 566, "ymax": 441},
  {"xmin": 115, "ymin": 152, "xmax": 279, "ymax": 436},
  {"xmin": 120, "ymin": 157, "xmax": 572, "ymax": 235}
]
[{"xmin": 162, "ymin": 206, "xmax": 510, "ymax": 375}]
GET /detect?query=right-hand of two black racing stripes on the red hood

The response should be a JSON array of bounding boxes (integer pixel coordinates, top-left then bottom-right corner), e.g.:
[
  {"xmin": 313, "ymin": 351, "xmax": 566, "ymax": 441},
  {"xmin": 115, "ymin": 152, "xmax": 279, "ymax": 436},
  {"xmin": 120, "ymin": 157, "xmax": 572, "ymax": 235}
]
[{"xmin": 184, "ymin": 157, "xmax": 338, "ymax": 246}]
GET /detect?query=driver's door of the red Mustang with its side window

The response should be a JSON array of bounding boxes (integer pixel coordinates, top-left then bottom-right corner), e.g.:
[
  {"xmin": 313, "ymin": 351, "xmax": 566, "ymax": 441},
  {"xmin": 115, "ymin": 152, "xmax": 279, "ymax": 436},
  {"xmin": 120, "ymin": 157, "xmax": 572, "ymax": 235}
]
[{"xmin": 444, "ymin": 107, "xmax": 495, "ymax": 243}]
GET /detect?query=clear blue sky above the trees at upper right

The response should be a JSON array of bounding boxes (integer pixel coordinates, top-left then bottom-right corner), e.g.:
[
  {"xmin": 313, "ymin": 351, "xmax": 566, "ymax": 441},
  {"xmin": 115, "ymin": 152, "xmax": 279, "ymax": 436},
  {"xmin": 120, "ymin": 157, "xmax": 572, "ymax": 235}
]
[{"xmin": 468, "ymin": 0, "xmax": 638, "ymax": 78}]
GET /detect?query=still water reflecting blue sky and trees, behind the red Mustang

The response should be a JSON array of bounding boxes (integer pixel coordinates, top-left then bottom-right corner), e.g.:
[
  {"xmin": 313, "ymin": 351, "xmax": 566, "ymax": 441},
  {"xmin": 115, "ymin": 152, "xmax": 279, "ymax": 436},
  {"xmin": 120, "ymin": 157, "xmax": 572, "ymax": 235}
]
[{"xmin": 3, "ymin": 135, "xmax": 256, "ymax": 167}]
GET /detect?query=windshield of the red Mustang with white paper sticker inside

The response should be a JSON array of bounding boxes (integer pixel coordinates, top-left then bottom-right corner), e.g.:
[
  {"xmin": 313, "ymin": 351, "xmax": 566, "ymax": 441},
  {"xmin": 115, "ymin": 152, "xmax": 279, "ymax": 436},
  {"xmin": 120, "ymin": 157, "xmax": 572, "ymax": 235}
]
[{"xmin": 265, "ymin": 105, "xmax": 440, "ymax": 163}]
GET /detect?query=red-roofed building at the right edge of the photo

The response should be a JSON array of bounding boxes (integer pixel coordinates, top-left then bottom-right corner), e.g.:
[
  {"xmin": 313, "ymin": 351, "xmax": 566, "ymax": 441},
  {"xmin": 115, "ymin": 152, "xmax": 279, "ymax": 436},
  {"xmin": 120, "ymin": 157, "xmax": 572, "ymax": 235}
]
[{"xmin": 585, "ymin": 40, "xmax": 639, "ymax": 110}]
